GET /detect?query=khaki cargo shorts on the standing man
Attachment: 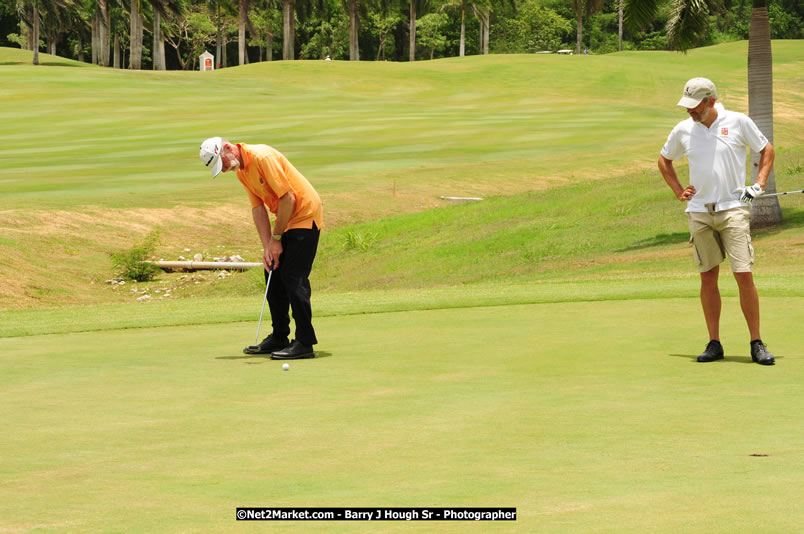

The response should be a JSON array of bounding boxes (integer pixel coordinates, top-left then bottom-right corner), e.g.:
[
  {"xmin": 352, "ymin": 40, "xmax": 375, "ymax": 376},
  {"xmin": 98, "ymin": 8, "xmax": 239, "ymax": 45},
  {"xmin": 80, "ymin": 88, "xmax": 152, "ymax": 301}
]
[{"xmin": 687, "ymin": 207, "xmax": 754, "ymax": 273}]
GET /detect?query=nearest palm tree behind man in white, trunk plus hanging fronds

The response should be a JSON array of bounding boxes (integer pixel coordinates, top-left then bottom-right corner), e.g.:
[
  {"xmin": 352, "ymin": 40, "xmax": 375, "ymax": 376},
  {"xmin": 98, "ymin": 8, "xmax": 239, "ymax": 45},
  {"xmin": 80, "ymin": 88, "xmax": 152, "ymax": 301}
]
[{"xmin": 625, "ymin": 0, "xmax": 782, "ymax": 227}]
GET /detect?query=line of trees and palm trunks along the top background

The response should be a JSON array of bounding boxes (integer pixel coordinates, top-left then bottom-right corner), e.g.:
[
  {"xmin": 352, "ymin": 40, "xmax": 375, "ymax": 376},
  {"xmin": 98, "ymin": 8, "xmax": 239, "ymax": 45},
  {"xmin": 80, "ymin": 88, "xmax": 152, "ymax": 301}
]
[{"xmin": 0, "ymin": 0, "xmax": 804, "ymax": 70}]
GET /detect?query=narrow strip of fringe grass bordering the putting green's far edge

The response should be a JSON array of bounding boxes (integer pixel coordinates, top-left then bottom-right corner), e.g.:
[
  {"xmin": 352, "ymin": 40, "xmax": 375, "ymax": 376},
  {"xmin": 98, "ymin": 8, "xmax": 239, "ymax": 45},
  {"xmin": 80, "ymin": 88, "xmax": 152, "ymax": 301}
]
[{"xmin": 0, "ymin": 272, "xmax": 804, "ymax": 339}]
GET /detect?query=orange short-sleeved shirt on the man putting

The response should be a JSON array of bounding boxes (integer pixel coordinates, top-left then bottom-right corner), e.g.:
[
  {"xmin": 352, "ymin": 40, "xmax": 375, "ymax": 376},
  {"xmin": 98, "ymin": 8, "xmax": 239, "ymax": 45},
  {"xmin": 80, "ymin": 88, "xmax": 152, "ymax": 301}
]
[{"xmin": 237, "ymin": 143, "xmax": 324, "ymax": 230}]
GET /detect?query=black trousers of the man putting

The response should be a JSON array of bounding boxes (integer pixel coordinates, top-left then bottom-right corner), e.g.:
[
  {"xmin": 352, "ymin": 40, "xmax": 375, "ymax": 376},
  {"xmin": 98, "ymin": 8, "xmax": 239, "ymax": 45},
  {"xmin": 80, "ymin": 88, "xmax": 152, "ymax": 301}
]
[{"xmin": 265, "ymin": 223, "xmax": 321, "ymax": 347}]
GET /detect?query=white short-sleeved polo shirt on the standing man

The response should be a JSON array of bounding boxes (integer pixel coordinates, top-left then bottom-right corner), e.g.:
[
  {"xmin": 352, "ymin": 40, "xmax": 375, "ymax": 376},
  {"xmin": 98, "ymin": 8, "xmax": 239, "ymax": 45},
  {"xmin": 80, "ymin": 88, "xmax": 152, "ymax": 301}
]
[{"xmin": 662, "ymin": 103, "xmax": 768, "ymax": 212}]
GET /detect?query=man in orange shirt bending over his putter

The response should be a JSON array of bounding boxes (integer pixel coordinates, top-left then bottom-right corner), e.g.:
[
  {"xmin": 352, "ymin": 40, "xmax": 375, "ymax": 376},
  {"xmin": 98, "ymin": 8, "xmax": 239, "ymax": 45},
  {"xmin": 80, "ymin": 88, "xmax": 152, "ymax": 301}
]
[{"xmin": 201, "ymin": 137, "xmax": 324, "ymax": 360}]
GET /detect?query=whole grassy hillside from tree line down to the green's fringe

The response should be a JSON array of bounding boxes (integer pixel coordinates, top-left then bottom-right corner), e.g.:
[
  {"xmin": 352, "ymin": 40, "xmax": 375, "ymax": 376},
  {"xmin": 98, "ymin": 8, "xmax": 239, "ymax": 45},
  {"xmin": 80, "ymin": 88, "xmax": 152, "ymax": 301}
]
[{"xmin": 0, "ymin": 41, "xmax": 804, "ymax": 309}]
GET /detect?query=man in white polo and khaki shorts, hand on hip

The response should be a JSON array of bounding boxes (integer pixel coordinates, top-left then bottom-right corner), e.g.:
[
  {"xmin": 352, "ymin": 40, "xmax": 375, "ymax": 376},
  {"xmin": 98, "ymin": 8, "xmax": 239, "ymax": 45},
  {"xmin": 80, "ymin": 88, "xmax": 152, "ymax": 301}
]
[{"xmin": 659, "ymin": 78, "xmax": 774, "ymax": 365}]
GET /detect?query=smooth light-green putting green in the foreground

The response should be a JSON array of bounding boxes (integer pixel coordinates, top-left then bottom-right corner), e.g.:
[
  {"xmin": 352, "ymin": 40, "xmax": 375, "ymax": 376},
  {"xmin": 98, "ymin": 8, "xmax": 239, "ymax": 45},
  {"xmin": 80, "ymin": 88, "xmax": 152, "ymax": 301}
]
[{"xmin": 0, "ymin": 297, "xmax": 804, "ymax": 533}]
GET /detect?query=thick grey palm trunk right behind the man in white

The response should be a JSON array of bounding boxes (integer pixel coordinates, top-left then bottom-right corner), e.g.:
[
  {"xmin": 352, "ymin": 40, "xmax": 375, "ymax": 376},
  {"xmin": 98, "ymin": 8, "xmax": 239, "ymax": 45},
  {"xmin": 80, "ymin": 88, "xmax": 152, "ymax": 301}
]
[{"xmin": 748, "ymin": 5, "xmax": 782, "ymax": 228}]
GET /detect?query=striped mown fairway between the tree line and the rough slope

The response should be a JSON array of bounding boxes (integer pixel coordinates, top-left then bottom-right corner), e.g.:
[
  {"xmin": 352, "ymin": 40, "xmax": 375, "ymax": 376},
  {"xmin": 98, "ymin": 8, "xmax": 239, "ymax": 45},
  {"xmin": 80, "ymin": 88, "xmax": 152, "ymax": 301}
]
[{"xmin": 0, "ymin": 41, "xmax": 801, "ymax": 213}]
